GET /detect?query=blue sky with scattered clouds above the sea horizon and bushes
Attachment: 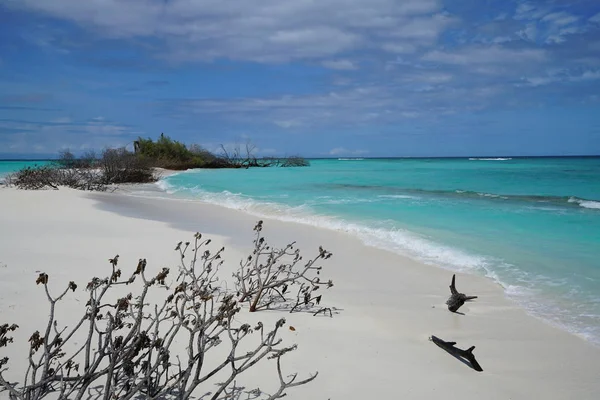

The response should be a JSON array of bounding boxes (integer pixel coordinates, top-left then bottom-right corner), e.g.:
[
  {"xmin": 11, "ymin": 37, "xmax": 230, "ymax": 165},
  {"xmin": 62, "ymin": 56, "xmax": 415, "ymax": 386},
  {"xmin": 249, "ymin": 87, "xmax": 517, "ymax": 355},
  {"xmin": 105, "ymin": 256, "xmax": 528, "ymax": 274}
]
[{"xmin": 0, "ymin": 0, "xmax": 600, "ymax": 157}]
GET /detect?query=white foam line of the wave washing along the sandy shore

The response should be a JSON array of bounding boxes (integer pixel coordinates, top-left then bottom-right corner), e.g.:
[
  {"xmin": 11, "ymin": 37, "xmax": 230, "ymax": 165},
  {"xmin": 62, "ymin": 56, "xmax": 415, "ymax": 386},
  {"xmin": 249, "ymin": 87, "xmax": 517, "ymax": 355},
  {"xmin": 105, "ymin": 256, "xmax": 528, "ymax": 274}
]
[{"xmin": 144, "ymin": 180, "xmax": 600, "ymax": 345}]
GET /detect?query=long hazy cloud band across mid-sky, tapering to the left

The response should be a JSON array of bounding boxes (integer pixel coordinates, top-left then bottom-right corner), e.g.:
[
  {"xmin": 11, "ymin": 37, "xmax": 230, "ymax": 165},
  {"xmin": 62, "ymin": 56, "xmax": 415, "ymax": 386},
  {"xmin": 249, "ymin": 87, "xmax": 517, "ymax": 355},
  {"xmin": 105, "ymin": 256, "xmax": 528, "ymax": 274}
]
[{"xmin": 153, "ymin": 68, "xmax": 538, "ymax": 133}]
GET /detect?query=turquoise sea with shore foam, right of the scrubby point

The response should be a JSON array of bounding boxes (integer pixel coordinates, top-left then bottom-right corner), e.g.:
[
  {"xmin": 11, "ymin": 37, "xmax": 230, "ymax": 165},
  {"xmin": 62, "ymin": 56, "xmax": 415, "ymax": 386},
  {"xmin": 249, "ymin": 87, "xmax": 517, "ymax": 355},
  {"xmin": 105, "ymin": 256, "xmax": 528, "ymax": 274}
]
[{"xmin": 159, "ymin": 158, "xmax": 600, "ymax": 344}]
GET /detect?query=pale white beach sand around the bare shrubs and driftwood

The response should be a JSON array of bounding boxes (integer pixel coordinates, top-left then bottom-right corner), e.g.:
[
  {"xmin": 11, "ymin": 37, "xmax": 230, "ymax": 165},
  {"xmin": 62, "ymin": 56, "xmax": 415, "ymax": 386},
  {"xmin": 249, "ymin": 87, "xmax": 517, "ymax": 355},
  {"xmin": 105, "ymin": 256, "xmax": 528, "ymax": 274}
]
[{"xmin": 0, "ymin": 189, "xmax": 600, "ymax": 400}]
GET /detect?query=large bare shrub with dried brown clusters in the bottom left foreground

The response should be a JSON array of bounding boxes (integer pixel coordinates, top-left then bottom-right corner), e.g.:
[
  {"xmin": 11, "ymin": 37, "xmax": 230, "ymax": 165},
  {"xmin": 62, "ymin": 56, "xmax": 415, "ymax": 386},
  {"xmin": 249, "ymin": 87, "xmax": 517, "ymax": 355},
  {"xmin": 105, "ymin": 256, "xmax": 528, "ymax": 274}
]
[{"xmin": 0, "ymin": 230, "xmax": 317, "ymax": 400}]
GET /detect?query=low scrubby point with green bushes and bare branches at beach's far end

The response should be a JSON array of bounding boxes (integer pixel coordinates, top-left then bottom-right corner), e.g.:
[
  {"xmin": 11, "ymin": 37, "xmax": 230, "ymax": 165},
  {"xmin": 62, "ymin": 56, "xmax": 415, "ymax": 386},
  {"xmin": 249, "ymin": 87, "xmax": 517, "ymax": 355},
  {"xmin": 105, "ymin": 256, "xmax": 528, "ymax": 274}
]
[{"xmin": 5, "ymin": 133, "xmax": 310, "ymax": 191}]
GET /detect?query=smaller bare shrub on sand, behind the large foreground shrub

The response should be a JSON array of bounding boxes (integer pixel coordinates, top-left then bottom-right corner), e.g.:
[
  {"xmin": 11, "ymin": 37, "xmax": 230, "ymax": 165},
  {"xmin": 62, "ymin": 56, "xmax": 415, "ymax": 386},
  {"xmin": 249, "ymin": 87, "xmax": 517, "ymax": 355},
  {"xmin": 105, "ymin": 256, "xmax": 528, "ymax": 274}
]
[{"xmin": 233, "ymin": 221, "xmax": 333, "ymax": 313}]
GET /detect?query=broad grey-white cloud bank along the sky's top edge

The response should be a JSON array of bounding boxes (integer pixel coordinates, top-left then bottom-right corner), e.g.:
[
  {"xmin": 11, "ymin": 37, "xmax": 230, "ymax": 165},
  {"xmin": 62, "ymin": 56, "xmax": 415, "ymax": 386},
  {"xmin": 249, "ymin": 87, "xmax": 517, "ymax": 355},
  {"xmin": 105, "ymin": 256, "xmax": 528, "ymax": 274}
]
[{"xmin": 8, "ymin": 0, "xmax": 453, "ymax": 62}]
